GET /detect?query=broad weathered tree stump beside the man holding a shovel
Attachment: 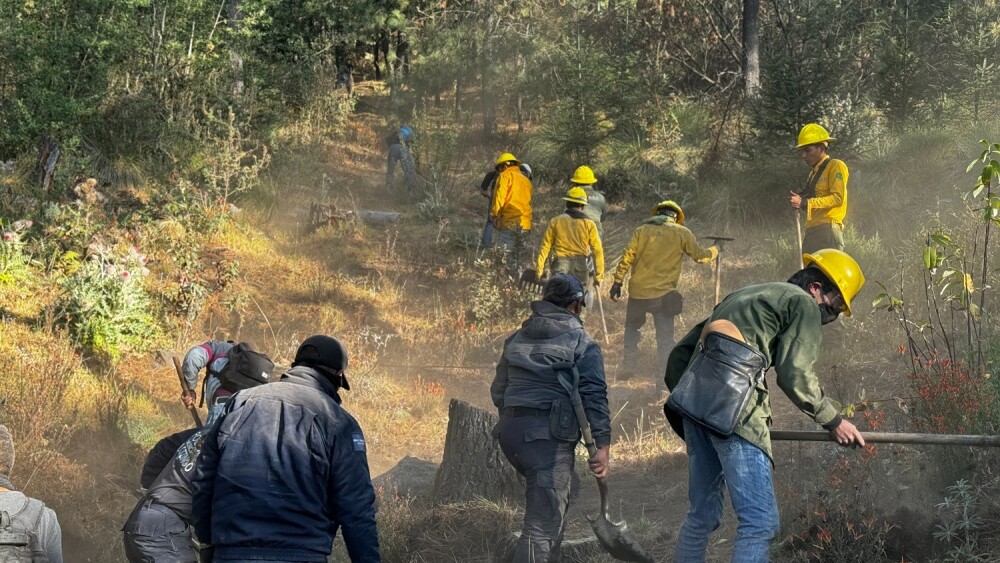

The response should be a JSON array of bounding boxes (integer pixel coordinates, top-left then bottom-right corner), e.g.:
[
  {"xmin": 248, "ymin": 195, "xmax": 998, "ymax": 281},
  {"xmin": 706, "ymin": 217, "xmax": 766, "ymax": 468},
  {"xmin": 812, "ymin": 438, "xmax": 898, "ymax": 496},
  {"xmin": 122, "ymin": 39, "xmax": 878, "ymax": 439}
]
[{"xmin": 433, "ymin": 399, "xmax": 524, "ymax": 502}]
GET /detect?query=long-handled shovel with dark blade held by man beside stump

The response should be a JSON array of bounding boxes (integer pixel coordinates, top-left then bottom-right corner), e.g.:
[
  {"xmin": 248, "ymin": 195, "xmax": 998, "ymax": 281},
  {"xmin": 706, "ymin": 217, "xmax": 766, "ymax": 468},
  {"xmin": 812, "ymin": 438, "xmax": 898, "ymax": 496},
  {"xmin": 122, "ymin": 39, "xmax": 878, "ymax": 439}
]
[{"xmin": 552, "ymin": 362, "xmax": 654, "ymax": 563}]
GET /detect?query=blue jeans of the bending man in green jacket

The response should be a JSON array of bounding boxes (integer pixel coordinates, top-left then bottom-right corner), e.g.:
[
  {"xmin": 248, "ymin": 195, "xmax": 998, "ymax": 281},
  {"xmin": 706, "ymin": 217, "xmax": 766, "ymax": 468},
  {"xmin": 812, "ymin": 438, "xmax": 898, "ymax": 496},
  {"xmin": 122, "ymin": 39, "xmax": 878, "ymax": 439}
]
[{"xmin": 674, "ymin": 418, "xmax": 781, "ymax": 563}]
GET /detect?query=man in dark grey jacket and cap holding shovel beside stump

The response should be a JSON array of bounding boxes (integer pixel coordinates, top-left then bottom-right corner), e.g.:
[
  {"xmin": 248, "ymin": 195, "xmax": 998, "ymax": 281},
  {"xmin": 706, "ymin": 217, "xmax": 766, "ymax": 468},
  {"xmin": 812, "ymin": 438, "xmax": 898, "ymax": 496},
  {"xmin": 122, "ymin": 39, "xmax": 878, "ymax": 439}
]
[{"xmin": 490, "ymin": 274, "xmax": 611, "ymax": 563}]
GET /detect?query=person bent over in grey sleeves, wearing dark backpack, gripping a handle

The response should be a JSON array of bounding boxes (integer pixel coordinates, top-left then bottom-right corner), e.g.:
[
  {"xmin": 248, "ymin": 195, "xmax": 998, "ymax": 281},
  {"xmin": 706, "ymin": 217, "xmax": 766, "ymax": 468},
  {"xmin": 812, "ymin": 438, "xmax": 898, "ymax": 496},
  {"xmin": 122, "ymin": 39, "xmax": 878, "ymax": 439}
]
[{"xmin": 181, "ymin": 340, "xmax": 274, "ymax": 419}]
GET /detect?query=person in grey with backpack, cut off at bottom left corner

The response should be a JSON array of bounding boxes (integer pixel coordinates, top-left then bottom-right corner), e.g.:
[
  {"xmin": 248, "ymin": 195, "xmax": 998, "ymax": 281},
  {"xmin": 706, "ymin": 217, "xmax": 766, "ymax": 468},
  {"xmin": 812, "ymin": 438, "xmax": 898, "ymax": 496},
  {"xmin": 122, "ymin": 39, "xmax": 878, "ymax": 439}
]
[{"xmin": 0, "ymin": 424, "xmax": 63, "ymax": 563}]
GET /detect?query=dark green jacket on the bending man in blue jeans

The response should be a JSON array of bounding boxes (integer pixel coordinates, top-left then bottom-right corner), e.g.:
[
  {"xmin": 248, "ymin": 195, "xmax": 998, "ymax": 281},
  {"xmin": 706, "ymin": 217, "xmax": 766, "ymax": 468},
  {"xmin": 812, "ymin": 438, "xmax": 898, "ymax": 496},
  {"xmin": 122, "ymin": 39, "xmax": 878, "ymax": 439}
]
[{"xmin": 664, "ymin": 282, "xmax": 840, "ymax": 459}]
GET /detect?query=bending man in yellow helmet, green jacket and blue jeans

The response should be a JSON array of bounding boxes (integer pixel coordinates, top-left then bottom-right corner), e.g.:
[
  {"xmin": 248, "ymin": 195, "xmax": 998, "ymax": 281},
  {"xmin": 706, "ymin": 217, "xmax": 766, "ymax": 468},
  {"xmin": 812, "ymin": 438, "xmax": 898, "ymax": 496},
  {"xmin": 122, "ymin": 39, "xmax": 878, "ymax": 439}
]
[{"xmin": 664, "ymin": 249, "xmax": 865, "ymax": 563}]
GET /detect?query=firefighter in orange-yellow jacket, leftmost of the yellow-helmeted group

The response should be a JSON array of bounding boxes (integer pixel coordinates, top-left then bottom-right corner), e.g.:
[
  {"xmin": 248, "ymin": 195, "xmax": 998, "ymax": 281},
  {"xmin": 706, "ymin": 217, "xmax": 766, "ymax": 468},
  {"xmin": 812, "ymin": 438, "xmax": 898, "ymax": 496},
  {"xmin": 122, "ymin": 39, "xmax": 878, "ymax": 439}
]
[{"xmin": 490, "ymin": 152, "xmax": 531, "ymax": 269}]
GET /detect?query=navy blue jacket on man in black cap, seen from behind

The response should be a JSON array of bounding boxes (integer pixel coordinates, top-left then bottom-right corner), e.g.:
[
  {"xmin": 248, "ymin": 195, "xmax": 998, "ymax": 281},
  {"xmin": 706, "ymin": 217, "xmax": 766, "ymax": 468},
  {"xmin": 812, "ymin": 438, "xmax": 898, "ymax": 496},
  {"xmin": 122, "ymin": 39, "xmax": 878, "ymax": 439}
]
[{"xmin": 191, "ymin": 366, "xmax": 381, "ymax": 563}]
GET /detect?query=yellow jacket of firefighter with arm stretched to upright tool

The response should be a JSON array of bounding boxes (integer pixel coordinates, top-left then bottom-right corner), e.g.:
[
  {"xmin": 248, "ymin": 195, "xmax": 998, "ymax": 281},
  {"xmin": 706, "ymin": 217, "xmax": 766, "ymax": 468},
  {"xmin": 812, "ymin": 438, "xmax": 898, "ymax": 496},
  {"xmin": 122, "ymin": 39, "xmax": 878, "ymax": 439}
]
[{"xmin": 615, "ymin": 215, "xmax": 719, "ymax": 299}]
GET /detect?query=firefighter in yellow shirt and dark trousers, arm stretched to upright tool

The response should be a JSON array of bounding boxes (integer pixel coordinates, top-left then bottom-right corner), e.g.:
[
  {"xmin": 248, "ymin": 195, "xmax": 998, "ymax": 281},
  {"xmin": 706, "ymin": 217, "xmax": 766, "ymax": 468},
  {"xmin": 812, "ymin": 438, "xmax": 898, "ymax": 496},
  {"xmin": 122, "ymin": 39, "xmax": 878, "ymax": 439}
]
[{"xmin": 611, "ymin": 200, "xmax": 719, "ymax": 381}]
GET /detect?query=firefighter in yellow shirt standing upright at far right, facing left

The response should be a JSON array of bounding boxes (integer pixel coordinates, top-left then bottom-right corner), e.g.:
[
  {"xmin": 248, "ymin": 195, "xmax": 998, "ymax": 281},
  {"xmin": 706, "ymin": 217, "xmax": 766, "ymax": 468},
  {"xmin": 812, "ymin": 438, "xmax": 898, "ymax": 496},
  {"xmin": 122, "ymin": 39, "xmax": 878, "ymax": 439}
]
[{"xmin": 789, "ymin": 123, "xmax": 848, "ymax": 254}]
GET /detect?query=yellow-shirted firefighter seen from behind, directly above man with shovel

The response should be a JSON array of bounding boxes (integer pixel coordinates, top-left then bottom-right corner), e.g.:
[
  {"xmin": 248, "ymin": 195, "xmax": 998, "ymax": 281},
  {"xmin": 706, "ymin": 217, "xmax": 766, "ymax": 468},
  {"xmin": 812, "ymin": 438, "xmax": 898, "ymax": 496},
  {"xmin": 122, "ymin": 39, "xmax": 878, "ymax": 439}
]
[{"xmin": 535, "ymin": 187, "xmax": 604, "ymax": 290}]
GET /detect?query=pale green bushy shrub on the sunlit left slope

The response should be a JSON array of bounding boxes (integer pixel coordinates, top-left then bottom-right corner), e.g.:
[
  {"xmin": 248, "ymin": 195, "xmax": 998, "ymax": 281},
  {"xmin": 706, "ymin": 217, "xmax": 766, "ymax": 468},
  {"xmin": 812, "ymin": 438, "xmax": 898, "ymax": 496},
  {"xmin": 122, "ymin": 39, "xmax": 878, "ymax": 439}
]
[{"xmin": 56, "ymin": 248, "xmax": 159, "ymax": 360}]
